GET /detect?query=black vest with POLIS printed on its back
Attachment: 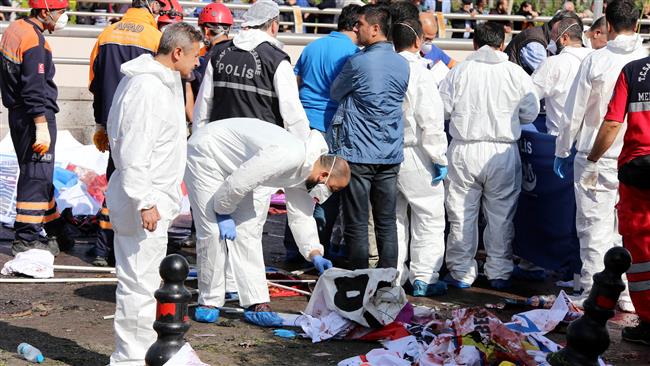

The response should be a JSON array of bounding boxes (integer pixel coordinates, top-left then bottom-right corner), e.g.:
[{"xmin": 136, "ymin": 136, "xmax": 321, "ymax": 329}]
[{"xmin": 210, "ymin": 41, "xmax": 289, "ymax": 126}]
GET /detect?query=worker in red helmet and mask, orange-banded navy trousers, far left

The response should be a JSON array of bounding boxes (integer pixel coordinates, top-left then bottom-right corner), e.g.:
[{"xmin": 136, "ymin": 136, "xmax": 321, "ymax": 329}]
[{"xmin": 0, "ymin": 0, "xmax": 74, "ymax": 255}]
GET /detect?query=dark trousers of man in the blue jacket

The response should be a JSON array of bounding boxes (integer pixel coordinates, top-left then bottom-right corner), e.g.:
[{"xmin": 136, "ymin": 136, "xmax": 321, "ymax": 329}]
[{"xmin": 341, "ymin": 163, "xmax": 400, "ymax": 269}]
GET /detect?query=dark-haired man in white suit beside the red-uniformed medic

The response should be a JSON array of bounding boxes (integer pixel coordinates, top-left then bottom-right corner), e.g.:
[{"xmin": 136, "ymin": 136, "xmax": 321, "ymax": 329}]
[{"xmin": 553, "ymin": 0, "xmax": 648, "ymax": 312}]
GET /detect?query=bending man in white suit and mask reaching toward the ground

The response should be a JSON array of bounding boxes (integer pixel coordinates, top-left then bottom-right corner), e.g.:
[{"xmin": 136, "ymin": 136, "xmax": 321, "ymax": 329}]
[{"xmin": 185, "ymin": 118, "xmax": 350, "ymax": 325}]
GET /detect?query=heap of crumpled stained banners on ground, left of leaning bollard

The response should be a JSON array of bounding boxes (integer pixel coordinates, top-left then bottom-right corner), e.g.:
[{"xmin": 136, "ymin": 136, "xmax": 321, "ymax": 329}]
[{"xmin": 339, "ymin": 292, "xmax": 604, "ymax": 366}]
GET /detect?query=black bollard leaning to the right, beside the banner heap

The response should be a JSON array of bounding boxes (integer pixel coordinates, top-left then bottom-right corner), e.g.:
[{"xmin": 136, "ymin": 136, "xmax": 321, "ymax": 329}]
[{"xmin": 546, "ymin": 247, "xmax": 632, "ymax": 366}]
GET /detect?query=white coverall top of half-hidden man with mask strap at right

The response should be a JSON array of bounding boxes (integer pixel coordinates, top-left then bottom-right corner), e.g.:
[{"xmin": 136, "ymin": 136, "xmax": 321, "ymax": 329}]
[{"xmin": 531, "ymin": 47, "xmax": 593, "ymax": 136}]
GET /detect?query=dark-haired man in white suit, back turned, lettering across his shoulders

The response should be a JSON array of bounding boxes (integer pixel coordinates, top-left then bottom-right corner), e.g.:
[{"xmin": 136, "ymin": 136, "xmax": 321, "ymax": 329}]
[{"xmin": 440, "ymin": 23, "xmax": 539, "ymax": 289}]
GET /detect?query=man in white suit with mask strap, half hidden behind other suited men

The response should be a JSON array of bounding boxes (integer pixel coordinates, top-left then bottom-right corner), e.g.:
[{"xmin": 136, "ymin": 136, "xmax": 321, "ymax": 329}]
[{"xmin": 532, "ymin": 18, "xmax": 593, "ymax": 136}]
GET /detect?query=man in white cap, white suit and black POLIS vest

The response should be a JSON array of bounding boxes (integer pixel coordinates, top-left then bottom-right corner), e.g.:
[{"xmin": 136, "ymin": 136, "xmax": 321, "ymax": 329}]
[{"xmin": 193, "ymin": 0, "xmax": 309, "ymax": 323}]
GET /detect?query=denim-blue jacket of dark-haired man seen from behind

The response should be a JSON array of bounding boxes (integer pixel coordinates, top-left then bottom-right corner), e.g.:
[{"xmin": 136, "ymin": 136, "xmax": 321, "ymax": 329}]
[{"xmin": 327, "ymin": 42, "xmax": 409, "ymax": 164}]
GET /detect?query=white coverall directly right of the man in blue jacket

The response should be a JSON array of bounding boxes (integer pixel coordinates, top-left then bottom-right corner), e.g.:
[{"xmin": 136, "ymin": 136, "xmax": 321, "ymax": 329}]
[{"xmin": 397, "ymin": 51, "xmax": 447, "ymax": 284}]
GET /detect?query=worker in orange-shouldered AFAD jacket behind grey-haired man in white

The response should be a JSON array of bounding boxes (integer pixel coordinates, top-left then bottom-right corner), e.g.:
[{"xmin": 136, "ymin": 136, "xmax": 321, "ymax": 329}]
[{"xmin": 89, "ymin": 0, "xmax": 164, "ymax": 266}]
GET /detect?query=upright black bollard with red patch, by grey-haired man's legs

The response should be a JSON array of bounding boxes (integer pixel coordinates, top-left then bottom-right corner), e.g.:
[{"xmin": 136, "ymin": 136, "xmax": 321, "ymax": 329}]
[{"xmin": 144, "ymin": 254, "xmax": 192, "ymax": 366}]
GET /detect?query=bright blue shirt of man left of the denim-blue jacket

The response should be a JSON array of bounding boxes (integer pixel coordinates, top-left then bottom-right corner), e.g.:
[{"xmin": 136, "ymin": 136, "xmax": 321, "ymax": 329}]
[{"xmin": 294, "ymin": 32, "xmax": 359, "ymax": 132}]
